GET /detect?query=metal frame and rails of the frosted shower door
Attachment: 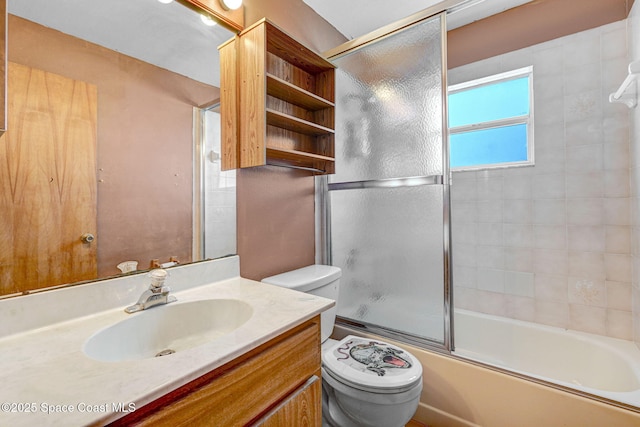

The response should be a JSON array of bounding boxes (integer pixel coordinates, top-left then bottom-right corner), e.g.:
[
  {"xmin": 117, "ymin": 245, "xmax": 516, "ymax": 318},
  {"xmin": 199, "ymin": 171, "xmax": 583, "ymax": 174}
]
[{"xmin": 315, "ymin": 0, "xmax": 460, "ymax": 354}]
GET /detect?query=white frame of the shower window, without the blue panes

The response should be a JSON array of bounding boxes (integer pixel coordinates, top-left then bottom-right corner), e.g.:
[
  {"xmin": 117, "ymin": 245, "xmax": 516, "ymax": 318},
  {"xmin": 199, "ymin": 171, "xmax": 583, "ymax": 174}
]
[{"xmin": 447, "ymin": 65, "xmax": 535, "ymax": 172}]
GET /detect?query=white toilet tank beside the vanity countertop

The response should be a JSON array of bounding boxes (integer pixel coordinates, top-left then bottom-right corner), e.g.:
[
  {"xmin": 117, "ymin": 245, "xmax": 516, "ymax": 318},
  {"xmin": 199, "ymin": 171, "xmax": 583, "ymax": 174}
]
[{"xmin": 262, "ymin": 264, "xmax": 342, "ymax": 342}]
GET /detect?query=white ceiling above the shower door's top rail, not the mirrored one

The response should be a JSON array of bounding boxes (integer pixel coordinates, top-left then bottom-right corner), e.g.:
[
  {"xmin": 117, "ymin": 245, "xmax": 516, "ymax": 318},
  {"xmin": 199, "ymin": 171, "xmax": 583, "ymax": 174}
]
[{"xmin": 302, "ymin": 0, "xmax": 532, "ymax": 39}]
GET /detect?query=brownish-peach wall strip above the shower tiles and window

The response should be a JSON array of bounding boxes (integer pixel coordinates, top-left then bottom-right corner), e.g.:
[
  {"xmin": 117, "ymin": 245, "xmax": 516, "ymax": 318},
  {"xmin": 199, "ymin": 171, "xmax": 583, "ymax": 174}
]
[{"xmin": 447, "ymin": 0, "xmax": 633, "ymax": 68}]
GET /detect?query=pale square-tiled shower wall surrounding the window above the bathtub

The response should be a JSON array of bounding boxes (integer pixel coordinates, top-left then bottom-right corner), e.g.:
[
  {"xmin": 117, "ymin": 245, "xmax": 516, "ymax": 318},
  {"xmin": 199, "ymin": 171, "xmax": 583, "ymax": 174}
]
[{"xmin": 449, "ymin": 19, "xmax": 637, "ymax": 339}]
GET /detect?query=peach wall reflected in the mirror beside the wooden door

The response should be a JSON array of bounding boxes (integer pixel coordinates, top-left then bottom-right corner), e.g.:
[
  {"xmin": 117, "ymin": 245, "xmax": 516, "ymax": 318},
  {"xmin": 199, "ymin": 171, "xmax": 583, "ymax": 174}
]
[{"xmin": 9, "ymin": 15, "xmax": 219, "ymax": 277}]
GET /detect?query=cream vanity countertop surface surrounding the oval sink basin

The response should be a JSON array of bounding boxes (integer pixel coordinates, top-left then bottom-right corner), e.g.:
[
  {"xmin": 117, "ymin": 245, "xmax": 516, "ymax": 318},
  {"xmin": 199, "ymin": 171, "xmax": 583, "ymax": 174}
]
[{"xmin": 0, "ymin": 277, "xmax": 334, "ymax": 427}]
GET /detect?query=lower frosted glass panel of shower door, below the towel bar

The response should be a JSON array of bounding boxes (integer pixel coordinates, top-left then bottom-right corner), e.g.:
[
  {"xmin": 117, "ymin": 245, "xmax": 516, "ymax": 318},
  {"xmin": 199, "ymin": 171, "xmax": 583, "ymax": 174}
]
[{"xmin": 330, "ymin": 185, "xmax": 444, "ymax": 343}]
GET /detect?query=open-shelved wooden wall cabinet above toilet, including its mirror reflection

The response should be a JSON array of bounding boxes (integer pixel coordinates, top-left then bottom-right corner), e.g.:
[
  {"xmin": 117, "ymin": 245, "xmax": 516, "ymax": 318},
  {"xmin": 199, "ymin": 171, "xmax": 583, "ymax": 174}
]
[{"xmin": 220, "ymin": 19, "xmax": 335, "ymax": 174}]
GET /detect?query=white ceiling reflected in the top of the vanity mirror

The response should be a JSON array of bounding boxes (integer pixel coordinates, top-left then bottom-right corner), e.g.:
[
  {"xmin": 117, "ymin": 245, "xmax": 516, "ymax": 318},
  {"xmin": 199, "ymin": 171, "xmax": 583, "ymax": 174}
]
[{"xmin": 7, "ymin": 0, "xmax": 233, "ymax": 87}]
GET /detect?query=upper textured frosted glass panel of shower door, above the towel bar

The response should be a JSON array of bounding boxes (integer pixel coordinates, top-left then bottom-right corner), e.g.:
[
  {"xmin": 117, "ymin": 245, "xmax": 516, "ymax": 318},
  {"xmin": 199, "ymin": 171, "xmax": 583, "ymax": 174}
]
[{"xmin": 329, "ymin": 17, "xmax": 443, "ymax": 182}]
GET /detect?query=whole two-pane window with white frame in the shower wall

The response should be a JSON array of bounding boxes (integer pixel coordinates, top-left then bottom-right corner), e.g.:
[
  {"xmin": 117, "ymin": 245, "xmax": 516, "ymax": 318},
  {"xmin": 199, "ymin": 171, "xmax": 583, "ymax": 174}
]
[{"xmin": 449, "ymin": 67, "xmax": 533, "ymax": 171}]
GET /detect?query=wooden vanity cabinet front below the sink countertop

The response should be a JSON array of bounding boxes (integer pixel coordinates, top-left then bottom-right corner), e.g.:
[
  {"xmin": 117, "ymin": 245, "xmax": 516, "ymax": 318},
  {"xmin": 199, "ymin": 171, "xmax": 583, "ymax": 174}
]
[{"xmin": 111, "ymin": 316, "xmax": 322, "ymax": 427}]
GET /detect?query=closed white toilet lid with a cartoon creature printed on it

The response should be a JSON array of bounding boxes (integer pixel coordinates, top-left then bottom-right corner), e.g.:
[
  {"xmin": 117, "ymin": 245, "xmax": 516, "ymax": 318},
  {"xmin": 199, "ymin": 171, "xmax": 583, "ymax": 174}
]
[{"xmin": 322, "ymin": 335, "xmax": 422, "ymax": 390}]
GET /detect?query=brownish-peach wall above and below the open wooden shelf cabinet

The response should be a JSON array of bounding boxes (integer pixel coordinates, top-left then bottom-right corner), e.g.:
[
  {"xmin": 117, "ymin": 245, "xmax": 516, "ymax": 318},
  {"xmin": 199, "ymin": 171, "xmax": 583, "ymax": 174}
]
[{"xmin": 237, "ymin": 0, "xmax": 346, "ymax": 280}]
